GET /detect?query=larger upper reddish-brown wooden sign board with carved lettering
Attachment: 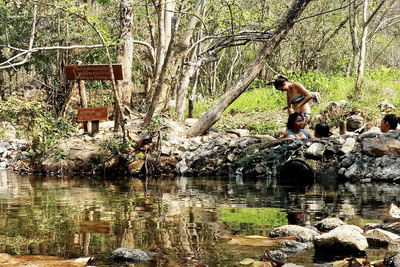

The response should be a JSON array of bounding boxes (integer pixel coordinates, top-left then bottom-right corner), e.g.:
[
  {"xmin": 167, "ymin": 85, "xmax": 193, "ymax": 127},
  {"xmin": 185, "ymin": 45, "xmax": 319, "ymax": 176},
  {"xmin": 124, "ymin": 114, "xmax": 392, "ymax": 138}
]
[{"xmin": 65, "ymin": 64, "xmax": 123, "ymax": 81}]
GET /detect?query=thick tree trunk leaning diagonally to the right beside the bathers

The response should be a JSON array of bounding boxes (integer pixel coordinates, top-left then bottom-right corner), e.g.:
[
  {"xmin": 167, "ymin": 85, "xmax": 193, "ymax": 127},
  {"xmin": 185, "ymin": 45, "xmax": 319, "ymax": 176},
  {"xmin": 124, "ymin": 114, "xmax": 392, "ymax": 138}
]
[{"xmin": 187, "ymin": 0, "xmax": 311, "ymax": 135}]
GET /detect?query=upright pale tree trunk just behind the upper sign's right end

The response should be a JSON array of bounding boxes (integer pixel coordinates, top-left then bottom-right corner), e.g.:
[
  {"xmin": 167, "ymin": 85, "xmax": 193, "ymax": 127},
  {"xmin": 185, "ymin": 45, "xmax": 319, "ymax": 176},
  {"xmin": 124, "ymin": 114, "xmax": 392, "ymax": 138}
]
[{"xmin": 117, "ymin": 0, "xmax": 134, "ymax": 105}]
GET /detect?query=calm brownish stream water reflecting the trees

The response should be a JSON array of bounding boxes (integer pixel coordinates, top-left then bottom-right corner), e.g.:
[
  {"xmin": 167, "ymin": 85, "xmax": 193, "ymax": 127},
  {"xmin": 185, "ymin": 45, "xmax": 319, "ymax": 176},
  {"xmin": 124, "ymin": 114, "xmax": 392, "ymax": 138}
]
[{"xmin": 0, "ymin": 172, "xmax": 400, "ymax": 266}]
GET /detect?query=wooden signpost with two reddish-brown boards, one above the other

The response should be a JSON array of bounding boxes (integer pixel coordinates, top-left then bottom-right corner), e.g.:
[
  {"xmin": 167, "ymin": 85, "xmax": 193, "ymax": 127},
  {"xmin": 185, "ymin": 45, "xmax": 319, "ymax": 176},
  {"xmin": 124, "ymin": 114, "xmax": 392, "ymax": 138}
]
[{"xmin": 65, "ymin": 64, "xmax": 123, "ymax": 135}]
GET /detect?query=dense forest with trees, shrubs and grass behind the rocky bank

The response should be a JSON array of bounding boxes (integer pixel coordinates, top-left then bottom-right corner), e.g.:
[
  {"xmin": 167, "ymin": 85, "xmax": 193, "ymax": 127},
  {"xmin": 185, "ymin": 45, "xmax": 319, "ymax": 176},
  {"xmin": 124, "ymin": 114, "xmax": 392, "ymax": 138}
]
[{"xmin": 0, "ymin": 0, "xmax": 400, "ymax": 144}]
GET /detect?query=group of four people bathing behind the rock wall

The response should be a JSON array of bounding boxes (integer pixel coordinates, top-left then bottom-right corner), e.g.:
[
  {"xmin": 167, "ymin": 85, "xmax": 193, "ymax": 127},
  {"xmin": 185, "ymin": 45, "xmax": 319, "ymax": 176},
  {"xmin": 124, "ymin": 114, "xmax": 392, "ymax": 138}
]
[{"xmin": 273, "ymin": 75, "xmax": 400, "ymax": 139}]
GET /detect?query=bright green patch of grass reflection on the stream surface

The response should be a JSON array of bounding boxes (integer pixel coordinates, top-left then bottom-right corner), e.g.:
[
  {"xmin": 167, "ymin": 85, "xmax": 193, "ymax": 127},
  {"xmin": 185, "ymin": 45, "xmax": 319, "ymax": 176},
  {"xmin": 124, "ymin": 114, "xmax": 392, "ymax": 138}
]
[{"xmin": 219, "ymin": 208, "xmax": 288, "ymax": 226}]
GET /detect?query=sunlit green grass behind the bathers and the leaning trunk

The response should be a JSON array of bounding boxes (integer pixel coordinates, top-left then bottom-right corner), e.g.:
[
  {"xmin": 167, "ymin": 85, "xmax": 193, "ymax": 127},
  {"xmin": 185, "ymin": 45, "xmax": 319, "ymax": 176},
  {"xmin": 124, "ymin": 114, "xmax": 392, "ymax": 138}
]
[{"xmin": 194, "ymin": 68, "xmax": 400, "ymax": 136}]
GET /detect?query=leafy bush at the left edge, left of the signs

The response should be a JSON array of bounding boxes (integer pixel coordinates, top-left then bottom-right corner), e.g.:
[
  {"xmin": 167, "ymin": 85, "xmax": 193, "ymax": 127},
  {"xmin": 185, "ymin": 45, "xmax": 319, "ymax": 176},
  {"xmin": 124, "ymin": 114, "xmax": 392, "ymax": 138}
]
[{"xmin": 0, "ymin": 95, "xmax": 73, "ymax": 150}]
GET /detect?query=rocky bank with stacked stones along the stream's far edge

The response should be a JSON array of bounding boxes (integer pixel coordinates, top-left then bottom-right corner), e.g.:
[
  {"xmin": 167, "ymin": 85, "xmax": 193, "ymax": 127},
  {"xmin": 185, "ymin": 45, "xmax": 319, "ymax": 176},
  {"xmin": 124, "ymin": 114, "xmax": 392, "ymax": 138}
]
[{"xmin": 0, "ymin": 121, "xmax": 400, "ymax": 182}]
